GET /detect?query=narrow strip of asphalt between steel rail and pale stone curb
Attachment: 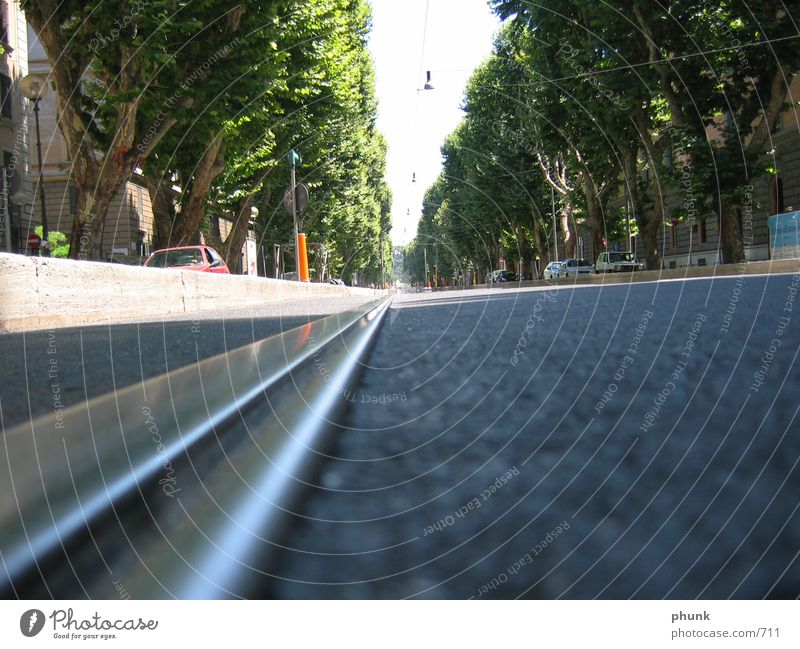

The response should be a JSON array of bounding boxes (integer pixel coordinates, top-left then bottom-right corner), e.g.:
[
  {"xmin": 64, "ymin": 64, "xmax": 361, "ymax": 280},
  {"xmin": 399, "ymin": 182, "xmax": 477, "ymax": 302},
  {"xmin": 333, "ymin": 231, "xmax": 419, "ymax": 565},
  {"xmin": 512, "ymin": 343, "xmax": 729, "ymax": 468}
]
[{"xmin": 0, "ymin": 294, "xmax": 379, "ymax": 430}]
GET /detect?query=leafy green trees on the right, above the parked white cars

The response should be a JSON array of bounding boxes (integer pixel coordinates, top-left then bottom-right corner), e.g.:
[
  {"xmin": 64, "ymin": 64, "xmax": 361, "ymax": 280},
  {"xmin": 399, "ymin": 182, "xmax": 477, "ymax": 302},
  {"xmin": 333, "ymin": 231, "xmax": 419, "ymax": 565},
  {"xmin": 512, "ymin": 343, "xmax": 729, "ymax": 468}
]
[{"xmin": 407, "ymin": 0, "xmax": 800, "ymax": 280}]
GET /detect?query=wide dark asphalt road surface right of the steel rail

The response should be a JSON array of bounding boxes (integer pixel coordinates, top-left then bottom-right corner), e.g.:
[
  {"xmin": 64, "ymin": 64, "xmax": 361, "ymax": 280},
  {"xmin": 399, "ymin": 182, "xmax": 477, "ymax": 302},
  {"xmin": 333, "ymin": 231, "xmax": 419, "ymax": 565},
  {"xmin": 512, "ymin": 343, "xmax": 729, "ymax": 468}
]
[{"xmin": 263, "ymin": 275, "xmax": 800, "ymax": 599}]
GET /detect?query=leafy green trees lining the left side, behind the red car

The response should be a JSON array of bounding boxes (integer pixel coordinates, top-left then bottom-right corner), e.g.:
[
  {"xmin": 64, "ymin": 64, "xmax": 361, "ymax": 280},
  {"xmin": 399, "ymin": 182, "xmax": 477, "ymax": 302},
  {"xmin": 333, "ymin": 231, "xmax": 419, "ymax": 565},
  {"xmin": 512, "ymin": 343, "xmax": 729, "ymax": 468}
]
[{"xmin": 22, "ymin": 0, "xmax": 391, "ymax": 280}]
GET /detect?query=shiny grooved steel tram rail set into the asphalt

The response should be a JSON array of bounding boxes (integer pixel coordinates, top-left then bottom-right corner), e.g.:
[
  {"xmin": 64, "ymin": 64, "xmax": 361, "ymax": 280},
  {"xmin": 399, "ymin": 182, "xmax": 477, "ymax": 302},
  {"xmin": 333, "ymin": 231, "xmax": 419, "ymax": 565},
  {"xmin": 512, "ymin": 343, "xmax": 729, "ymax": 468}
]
[{"xmin": 0, "ymin": 299, "xmax": 390, "ymax": 599}]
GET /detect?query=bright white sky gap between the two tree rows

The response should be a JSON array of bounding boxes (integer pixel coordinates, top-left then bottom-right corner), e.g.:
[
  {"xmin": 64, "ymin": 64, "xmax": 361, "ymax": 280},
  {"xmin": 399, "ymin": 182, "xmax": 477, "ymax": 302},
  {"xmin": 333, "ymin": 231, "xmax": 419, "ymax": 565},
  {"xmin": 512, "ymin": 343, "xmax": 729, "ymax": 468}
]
[{"xmin": 370, "ymin": 0, "xmax": 499, "ymax": 245}]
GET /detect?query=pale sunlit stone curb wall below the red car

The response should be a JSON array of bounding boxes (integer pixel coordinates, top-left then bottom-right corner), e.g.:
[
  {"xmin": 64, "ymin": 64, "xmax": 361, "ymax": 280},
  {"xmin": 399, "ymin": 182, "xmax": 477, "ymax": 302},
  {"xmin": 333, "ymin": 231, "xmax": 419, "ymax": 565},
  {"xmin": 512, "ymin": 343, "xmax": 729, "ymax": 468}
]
[{"xmin": 0, "ymin": 253, "xmax": 382, "ymax": 333}]
